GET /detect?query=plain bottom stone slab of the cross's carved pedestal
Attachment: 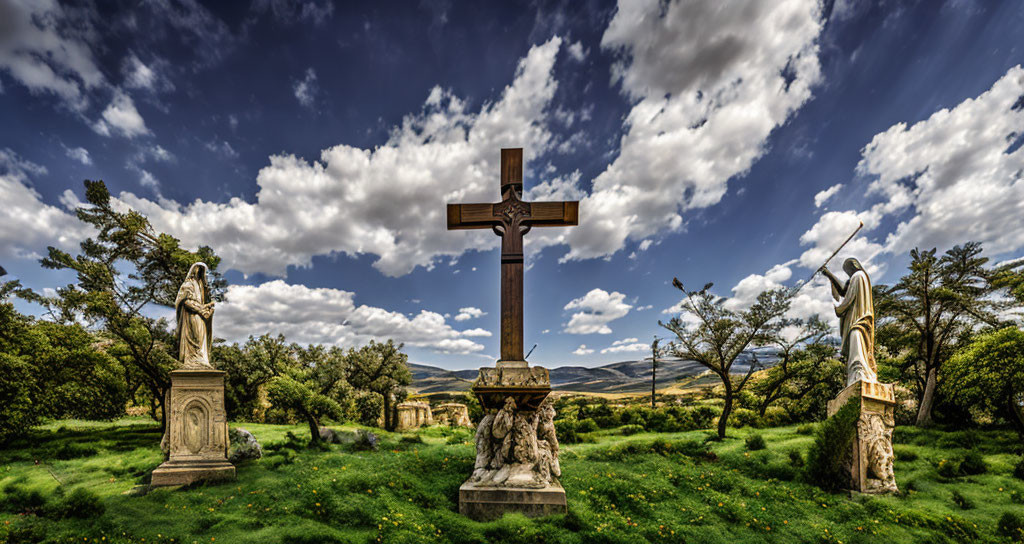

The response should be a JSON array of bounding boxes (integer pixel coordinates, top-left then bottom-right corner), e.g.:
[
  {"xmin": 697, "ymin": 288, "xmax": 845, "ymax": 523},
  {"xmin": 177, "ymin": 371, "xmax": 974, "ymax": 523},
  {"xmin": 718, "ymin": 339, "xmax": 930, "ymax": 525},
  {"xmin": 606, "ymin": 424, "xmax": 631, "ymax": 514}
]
[{"xmin": 459, "ymin": 482, "xmax": 568, "ymax": 521}]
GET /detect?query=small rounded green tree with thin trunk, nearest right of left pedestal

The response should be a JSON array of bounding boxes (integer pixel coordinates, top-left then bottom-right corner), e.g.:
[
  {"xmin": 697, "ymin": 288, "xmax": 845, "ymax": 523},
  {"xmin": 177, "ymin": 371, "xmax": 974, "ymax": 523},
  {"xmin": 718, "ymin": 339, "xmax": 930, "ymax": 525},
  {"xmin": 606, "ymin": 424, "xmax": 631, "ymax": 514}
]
[{"xmin": 267, "ymin": 345, "xmax": 352, "ymax": 445}]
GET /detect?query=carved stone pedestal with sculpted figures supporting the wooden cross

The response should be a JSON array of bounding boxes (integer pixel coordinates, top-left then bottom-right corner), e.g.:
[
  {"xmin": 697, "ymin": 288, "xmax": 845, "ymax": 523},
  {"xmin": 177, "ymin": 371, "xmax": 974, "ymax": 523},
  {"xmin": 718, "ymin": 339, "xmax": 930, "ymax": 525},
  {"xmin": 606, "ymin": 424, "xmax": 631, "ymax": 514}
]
[{"xmin": 459, "ymin": 361, "xmax": 566, "ymax": 520}]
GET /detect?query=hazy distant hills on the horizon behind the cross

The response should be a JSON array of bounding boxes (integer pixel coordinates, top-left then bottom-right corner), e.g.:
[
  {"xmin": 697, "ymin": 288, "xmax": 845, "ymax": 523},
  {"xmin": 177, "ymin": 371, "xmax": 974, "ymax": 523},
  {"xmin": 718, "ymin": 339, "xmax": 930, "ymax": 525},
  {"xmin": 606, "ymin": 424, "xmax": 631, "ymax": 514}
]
[{"xmin": 409, "ymin": 354, "xmax": 765, "ymax": 394}]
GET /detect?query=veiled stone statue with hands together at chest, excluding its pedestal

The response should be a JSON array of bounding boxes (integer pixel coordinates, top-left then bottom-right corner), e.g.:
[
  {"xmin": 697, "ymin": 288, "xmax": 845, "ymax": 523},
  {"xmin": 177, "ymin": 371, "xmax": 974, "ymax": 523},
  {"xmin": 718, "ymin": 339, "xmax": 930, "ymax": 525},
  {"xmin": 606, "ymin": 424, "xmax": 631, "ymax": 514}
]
[{"xmin": 174, "ymin": 262, "xmax": 213, "ymax": 369}]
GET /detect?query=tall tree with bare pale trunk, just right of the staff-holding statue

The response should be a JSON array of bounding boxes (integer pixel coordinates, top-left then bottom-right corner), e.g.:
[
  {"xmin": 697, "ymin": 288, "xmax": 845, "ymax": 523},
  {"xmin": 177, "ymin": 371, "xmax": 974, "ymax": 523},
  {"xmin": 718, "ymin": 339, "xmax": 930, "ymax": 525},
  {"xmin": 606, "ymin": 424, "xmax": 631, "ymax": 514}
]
[{"xmin": 874, "ymin": 242, "xmax": 998, "ymax": 426}]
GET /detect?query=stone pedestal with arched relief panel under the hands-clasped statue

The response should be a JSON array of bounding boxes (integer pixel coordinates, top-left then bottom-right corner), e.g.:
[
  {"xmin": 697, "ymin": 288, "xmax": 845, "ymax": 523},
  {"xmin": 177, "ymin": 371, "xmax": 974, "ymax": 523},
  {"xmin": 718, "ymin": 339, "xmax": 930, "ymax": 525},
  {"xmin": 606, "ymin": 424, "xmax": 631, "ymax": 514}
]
[{"xmin": 151, "ymin": 370, "xmax": 234, "ymax": 486}]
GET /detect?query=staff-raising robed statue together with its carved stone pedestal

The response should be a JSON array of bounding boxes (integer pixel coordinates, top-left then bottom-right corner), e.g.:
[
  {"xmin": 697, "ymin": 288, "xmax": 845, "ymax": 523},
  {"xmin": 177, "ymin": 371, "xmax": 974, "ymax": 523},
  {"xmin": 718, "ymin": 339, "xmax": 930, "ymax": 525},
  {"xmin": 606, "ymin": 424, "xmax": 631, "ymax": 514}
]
[{"xmin": 821, "ymin": 258, "xmax": 898, "ymax": 493}]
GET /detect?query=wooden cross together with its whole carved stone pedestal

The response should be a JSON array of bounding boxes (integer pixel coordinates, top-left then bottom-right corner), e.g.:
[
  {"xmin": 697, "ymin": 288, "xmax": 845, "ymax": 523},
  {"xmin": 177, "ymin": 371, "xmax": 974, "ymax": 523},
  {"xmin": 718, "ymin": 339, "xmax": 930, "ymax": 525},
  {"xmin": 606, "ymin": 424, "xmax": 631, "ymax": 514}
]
[{"xmin": 447, "ymin": 149, "xmax": 580, "ymax": 519}]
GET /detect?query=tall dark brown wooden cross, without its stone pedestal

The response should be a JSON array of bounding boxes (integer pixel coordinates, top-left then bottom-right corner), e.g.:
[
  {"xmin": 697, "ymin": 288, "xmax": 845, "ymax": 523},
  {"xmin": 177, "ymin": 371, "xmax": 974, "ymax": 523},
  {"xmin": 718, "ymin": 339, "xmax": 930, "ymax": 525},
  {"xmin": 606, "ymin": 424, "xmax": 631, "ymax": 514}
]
[{"xmin": 447, "ymin": 148, "xmax": 580, "ymax": 363}]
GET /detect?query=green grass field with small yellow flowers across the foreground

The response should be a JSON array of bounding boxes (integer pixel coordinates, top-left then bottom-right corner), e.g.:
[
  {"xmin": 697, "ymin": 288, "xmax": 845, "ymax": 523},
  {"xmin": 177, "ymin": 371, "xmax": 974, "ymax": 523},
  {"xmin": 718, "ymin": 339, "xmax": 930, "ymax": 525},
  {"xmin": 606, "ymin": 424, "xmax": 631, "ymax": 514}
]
[{"xmin": 0, "ymin": 420, "xmax": 1024, "ymax": 544}]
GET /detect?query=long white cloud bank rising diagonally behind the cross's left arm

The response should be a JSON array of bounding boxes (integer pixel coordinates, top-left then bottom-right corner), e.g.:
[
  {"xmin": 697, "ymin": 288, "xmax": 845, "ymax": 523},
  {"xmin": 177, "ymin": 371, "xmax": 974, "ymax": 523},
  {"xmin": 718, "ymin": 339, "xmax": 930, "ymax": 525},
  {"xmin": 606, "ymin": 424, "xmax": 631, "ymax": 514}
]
[{"xmin": 104, "ymin": 38, "xmax": 565, "ymax": 277}]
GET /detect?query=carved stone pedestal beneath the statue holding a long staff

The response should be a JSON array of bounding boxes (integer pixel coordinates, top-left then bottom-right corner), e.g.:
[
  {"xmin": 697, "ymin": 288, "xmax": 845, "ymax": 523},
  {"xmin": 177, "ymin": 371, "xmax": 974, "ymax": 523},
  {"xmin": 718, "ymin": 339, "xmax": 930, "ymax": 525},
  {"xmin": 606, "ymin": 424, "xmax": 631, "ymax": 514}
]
[{"xmin": 828, "ymin": 381, "xmax": 899, "ymax": 493}]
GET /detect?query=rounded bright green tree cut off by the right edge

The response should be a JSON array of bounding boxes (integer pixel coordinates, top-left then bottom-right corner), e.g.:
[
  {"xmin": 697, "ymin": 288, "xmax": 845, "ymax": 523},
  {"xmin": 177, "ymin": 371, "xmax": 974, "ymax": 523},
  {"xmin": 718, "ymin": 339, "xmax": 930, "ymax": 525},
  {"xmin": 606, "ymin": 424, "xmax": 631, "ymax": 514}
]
[{"xmin": 940, "ymin": 327, "xmax": 1024, "ymax": 436}]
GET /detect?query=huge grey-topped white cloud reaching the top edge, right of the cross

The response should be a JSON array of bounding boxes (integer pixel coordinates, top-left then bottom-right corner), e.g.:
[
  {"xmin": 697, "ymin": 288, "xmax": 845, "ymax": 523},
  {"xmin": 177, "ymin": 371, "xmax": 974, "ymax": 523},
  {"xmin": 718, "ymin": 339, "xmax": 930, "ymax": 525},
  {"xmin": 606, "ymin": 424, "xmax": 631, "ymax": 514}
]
[{"xmin": 563, "ymin": 0, "xmax": 823, "ymax": 259}]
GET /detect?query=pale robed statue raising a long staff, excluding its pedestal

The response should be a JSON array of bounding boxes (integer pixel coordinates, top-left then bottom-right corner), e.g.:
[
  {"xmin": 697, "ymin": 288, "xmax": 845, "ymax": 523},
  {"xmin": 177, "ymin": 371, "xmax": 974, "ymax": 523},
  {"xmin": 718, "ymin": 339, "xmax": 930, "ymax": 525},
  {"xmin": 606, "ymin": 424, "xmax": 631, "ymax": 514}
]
[{"xmin": 821, "ymin": 257, "xmax": 878, "ymax": 385}]
